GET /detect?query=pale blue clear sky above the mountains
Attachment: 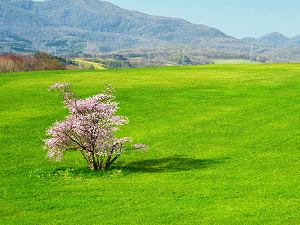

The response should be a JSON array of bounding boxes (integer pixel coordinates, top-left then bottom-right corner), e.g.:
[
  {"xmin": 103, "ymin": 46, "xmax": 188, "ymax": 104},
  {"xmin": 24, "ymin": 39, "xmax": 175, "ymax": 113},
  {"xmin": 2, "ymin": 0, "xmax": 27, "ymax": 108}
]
[{"xmin": 32, "ymin": 0, "xmax": 300, "ymax": 38}]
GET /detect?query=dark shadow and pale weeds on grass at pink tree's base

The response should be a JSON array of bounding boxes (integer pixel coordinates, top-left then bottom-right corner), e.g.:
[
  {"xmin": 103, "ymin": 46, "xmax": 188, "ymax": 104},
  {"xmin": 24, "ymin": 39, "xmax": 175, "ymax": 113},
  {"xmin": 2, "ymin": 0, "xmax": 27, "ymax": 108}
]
[{"xmin": 32, "ymin": 156, "xmax": 230, "ymax": 179}]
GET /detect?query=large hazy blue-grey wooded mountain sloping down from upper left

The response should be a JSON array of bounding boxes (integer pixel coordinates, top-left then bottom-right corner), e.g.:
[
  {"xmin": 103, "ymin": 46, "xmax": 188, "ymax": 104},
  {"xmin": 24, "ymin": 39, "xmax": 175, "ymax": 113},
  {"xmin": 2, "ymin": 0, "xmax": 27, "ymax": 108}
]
[{"xmin": 0, "ymin": 0, "xmax": 269, "ymax": 52}]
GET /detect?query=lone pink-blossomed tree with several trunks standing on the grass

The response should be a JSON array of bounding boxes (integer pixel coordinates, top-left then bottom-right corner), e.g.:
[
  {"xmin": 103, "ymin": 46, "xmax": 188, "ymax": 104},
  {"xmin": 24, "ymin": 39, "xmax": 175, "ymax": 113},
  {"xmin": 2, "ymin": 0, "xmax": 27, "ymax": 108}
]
[{"xmin": 43, "ymin": 83, "xmax": 148, "ymax": 170}]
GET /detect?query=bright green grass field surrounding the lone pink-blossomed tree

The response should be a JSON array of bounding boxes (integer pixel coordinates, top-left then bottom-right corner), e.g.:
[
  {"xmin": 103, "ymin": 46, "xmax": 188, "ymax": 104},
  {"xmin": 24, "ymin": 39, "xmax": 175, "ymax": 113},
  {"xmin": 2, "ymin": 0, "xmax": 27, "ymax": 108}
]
[{"xmin": 0, "ymin": 64, "xmax": 300, "ymax": 225}]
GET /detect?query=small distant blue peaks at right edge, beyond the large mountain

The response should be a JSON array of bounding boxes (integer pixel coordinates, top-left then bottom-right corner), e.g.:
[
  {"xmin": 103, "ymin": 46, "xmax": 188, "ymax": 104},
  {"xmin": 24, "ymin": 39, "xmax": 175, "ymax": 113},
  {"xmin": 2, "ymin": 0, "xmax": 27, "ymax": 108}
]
[{"xmin": 242, "ymin": 32, "xmax": 300, "ymax": 47}]
